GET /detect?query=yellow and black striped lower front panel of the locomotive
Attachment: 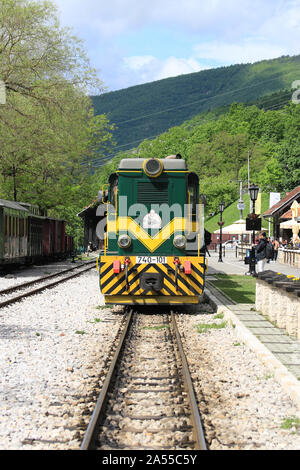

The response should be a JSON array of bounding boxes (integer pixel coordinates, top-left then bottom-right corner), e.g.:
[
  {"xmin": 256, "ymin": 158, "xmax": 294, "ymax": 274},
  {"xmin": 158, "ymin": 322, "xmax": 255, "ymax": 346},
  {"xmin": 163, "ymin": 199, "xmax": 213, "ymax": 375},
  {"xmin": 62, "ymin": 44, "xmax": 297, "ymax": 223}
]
[{"xmin": 99, "ymin": 256, "xmax": 205, "ymax": 304}]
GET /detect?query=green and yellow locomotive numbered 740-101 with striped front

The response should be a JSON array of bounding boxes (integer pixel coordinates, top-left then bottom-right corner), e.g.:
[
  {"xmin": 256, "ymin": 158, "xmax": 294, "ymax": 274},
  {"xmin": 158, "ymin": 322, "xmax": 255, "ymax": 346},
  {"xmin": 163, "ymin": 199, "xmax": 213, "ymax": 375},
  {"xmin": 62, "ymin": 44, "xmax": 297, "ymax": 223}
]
[{"xmin": 98, "ymin": 158, "xmax": 205, "ymax": 305}]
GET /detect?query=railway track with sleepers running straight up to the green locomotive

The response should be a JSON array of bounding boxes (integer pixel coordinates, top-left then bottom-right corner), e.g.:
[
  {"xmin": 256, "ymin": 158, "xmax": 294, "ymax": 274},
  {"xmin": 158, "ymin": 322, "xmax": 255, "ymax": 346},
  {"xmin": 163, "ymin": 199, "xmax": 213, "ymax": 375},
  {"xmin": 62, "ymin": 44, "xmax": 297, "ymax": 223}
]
[{"xmin": 80, "ymin": 310, "xmax": 206, "ymax": 450}]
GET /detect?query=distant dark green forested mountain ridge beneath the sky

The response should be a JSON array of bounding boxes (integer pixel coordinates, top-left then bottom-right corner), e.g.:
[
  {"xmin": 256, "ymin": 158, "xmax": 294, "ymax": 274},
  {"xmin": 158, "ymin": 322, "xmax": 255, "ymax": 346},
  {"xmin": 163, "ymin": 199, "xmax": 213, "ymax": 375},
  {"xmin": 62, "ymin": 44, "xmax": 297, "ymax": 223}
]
[{"xmin": 92, "ymin": 56, "xmax": 300, "ymax": 149}]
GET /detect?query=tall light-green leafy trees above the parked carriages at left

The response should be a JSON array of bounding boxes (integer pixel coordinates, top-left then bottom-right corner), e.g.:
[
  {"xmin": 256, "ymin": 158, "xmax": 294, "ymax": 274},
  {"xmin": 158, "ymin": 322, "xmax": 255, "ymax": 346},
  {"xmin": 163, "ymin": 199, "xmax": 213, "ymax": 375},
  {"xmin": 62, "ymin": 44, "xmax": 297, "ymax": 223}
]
[{"xmin": 0, "ymin": 0, "xmax": 113, "ymax": 242}]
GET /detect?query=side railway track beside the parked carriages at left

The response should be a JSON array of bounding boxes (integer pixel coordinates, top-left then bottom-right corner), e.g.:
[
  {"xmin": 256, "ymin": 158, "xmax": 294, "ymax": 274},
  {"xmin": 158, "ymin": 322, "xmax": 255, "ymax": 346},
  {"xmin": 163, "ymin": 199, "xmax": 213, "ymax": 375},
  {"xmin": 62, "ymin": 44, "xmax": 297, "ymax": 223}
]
[{"xmin": 0, "ymin": 260, "xmax": 96, "ymax": 308}]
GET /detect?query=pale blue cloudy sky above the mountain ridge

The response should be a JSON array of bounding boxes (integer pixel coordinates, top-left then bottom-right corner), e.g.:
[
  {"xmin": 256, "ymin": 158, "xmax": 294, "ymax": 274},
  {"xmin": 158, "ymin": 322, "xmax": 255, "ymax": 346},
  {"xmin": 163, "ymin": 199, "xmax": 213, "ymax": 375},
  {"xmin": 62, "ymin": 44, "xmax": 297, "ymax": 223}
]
[{"xmin": 54, "ymin": 0, "xmax": 300, "ymax": 91}]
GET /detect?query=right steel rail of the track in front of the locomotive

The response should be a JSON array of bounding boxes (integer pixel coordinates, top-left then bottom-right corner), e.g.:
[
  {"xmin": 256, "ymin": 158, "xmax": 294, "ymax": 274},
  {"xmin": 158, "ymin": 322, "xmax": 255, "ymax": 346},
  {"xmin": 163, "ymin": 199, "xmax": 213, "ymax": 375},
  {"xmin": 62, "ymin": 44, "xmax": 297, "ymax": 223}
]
[{"xmin": 171, "ymin": 312, "xmax": 207, "ymax": 450}]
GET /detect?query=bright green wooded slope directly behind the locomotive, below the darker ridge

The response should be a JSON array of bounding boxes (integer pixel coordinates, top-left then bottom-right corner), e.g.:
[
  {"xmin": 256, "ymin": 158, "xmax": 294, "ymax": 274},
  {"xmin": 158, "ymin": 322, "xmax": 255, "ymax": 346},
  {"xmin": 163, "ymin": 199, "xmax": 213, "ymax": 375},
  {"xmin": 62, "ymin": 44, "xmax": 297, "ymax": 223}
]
[{"xmin": 99, "ymin": 103, "xmax": 300, "ymax": 215}]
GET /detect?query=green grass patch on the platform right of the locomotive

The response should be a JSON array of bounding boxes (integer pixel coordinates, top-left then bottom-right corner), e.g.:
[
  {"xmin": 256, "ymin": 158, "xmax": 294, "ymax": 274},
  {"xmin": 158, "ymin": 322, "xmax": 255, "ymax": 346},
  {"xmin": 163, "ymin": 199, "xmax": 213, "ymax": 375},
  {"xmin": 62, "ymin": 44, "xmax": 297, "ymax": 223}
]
[{"xmin": 210, "ymin": 274, "xmax": 256, "ymax": 304}]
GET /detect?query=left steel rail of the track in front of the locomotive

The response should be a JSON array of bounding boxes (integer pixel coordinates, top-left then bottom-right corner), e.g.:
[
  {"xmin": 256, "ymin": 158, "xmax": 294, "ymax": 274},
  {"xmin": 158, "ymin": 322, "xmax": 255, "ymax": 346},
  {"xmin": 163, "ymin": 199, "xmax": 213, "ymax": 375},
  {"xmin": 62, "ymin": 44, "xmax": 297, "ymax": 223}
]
[{"xmin": 80, "ymin": 310, "xmax": 133, "ymax": 450}]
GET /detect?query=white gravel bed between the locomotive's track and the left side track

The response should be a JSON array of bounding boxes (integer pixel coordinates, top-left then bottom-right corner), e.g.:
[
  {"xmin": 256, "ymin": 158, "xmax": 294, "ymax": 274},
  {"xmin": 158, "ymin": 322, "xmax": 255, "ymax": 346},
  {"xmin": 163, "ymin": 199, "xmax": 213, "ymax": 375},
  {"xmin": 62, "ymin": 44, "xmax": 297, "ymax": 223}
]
[{"xmin": 0, "ymin": 270, "xmax": 123, "ymax": 449}]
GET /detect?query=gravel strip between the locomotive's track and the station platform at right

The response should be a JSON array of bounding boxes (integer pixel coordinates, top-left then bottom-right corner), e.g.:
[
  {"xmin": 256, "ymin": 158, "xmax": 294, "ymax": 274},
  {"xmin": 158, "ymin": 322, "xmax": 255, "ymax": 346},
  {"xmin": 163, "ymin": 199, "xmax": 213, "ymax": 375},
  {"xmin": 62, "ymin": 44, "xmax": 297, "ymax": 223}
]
[{"xmin": 178, "ymin": 304, "xmax": 300, "ymax": 450}]
